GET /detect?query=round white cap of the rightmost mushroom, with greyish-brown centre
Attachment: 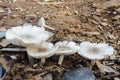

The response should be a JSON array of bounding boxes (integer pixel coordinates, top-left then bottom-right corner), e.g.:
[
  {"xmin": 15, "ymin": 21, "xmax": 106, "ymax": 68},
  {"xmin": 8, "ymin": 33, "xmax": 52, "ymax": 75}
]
[{"xmin": 78, "ymin": 42, "xmax": 114, "ymax": 60}]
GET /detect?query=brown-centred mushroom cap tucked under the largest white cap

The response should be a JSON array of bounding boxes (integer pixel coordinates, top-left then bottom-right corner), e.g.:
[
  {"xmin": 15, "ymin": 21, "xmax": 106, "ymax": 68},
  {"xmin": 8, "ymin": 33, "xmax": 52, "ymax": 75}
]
[{"xmin": 27, "ymin": 42, "xmax": 57, "ymax": 59}]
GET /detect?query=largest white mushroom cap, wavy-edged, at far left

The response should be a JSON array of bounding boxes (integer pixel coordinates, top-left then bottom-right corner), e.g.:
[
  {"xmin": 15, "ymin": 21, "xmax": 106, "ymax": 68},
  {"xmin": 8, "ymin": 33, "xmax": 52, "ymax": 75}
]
[{"xmin": 6, "ymin": 24, "xmax": 53, "ymax": 47}]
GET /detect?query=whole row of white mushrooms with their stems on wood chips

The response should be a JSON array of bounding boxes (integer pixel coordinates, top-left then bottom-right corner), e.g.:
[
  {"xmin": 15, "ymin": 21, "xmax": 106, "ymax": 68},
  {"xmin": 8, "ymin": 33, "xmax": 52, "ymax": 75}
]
[{"xmin": 6, "ymin": 17, "xmax": 114, "ymax": 65}]
